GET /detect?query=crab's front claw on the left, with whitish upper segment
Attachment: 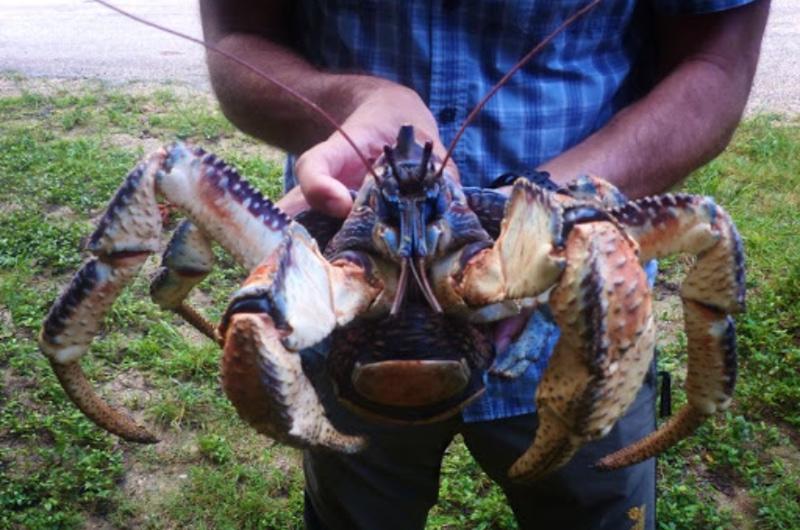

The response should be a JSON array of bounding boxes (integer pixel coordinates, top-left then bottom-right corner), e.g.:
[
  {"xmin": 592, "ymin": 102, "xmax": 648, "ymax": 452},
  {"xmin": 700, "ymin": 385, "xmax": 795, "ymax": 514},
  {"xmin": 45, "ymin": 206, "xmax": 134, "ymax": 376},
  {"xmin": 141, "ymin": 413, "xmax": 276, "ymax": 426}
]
[{"xmin": 220, "ymin": 224, "xmax": 383, "ymax": 452}]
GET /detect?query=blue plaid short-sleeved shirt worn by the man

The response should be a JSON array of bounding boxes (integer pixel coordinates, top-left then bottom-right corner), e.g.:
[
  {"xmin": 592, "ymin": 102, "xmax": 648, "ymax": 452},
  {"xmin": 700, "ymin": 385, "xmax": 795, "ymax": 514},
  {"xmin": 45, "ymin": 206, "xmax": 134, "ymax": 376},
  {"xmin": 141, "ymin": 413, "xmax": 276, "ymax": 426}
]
[{"xmin": 286, "ymin": 0, "xmax": 751, "ymax": 421}]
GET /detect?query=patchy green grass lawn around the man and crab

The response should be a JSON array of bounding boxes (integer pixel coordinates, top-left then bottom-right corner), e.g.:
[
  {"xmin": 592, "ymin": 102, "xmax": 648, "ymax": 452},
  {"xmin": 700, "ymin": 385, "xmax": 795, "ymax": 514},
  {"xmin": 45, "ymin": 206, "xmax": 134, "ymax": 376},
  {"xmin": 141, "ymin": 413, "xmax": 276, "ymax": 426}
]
[{"xmin": 0, "ymin": 75, "xmax": 800, "ymax": 529}]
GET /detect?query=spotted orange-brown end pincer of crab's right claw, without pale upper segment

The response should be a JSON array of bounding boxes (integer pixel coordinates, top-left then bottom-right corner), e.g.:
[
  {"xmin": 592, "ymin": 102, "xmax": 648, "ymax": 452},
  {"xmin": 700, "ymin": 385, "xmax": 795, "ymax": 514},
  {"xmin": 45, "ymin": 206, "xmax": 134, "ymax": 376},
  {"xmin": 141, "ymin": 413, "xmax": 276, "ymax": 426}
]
[{"xmin": 509, "ymin": 222, "xmax": 655, "ymax": 481}]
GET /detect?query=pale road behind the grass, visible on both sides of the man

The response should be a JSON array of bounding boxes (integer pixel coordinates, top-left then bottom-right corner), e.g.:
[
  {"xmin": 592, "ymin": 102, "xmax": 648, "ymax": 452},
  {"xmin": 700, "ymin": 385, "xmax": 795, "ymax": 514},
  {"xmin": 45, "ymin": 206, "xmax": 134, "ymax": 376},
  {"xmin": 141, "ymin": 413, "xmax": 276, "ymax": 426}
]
[{"xmin": 0, "ymin": 0, "xmax": 800, "ymax": 114}]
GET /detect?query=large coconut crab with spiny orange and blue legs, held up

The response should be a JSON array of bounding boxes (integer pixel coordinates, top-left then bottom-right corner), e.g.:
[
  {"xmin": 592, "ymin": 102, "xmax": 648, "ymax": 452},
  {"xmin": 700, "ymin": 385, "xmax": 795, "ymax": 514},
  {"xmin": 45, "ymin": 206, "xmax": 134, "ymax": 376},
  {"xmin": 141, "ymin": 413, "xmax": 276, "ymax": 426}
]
[{"xmin": 40, "ymin": 119, "xmax": 744, "ymax": 480}]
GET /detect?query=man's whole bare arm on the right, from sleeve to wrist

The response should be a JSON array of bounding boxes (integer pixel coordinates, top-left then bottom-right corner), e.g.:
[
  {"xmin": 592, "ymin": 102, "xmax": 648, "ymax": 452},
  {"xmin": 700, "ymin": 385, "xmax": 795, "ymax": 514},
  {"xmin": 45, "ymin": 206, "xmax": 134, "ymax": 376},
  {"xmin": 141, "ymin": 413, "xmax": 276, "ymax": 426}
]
[{"xmin": 542, "ymin": 0, "xmax": 769, "ymax": 197}]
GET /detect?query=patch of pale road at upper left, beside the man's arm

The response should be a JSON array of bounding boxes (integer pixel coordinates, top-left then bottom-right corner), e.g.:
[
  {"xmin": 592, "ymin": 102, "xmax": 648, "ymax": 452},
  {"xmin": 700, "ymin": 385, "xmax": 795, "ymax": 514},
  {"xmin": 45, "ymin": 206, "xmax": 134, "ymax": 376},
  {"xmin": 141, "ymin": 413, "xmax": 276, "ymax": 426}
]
[{"xmin": 0, "ymin": 0, "xmax": 209, "ymax": 88}]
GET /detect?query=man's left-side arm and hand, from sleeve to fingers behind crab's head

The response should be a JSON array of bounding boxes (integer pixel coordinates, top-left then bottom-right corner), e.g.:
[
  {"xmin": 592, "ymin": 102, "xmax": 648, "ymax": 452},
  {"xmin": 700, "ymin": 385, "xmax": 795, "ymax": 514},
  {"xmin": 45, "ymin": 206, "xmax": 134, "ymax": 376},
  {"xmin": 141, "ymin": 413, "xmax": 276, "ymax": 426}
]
[{"xmin": 200, "ymin": 0, "xmax": 457, "ymax": 217}]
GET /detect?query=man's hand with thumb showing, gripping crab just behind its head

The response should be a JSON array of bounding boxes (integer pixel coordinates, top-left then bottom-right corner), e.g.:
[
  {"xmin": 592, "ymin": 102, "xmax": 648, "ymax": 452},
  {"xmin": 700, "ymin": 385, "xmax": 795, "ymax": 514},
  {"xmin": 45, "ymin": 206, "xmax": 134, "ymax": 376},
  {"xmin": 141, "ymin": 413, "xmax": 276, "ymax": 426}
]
[{"xmin": 295, "ymin": 81, "xmax": 458, "ymax": 217}]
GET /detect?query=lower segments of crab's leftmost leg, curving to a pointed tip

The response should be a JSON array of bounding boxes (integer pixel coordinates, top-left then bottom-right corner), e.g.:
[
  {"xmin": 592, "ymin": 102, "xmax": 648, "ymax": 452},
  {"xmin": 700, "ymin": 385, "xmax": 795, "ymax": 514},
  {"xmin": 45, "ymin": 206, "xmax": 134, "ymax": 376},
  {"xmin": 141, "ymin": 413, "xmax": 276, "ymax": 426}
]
[{"xmin": 39, "ymin": 159, "xmax": 161, "ymax": 443}]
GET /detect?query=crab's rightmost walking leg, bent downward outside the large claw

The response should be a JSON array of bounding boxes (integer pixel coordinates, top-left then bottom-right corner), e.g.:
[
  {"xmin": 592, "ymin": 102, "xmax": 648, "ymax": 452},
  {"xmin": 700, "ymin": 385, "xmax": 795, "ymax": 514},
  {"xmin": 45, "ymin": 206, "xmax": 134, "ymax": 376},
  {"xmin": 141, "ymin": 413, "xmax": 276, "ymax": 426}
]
[{"xmin": 598, "ymin": 195, "xmax": 745, "ymax": 469}]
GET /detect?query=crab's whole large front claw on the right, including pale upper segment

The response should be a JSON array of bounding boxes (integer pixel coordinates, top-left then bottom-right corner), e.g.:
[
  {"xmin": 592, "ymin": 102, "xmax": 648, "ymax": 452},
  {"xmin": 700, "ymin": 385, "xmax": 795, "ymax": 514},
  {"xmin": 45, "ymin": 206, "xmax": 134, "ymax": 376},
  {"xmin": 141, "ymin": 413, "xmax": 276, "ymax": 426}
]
[{"xmin": 434, "ymin": 181, "xmax": 654, "ymax": 480}]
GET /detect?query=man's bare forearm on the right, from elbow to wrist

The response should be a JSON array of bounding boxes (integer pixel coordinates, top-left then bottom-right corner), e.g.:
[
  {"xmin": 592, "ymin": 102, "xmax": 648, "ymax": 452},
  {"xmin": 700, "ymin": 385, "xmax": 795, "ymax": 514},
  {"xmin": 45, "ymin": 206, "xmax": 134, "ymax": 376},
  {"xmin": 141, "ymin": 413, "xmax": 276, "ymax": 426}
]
[{"xmin": 542, "ymin": 56, "xmax": 749, "ymax": 197}]
